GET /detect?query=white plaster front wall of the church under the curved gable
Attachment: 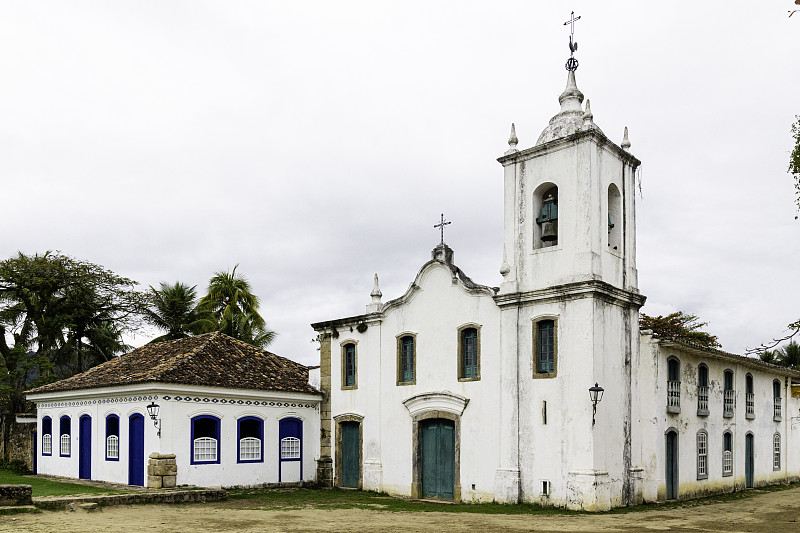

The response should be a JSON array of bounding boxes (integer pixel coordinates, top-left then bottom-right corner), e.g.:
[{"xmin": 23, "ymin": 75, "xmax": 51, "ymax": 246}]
[{"xmin": 331, "ymin": 263, "xmax": 500, "ymax": 501}]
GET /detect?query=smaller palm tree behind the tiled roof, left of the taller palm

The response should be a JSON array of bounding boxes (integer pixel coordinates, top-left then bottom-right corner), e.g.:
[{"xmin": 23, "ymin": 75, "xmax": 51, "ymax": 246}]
[{"xmin": 144, "ymin": 282, "xmax": 209, "ymax": 342}]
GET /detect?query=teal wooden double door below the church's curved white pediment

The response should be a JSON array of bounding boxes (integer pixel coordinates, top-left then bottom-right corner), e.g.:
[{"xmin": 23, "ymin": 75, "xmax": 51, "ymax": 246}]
[{"xmin": 420, "ymin": 419, "xmax": 455, "ymax": 500}]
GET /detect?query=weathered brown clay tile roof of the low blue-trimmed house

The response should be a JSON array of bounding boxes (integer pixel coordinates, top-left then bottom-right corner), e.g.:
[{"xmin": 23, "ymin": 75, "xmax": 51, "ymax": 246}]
[{"xmin": 27, "ymin": 332, "xmax": 319, "ymax": 394}]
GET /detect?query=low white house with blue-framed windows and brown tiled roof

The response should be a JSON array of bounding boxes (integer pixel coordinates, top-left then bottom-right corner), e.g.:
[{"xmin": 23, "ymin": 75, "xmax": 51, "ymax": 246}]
[{"xmin": 27, "ymin": 333, "xmax": 321, "ymax": 488}]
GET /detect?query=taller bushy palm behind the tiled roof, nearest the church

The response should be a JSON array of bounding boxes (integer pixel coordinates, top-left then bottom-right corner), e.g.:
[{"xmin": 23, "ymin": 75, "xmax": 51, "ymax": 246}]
[{"xmin": 199, "ymin": 265, "xmax": 276, "ymax": 349}]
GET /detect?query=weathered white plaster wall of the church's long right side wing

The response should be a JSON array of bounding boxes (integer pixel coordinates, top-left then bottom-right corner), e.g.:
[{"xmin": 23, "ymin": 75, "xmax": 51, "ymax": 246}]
[{"xmin": 640, "ymin": 335, "xmax": 800, "ymax": 501}]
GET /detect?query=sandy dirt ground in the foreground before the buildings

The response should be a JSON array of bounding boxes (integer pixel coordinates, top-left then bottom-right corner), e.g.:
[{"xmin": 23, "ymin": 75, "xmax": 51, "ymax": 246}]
[{"xmin": 0, "ymin": 488, "xmax": 800, "ymax": 533}]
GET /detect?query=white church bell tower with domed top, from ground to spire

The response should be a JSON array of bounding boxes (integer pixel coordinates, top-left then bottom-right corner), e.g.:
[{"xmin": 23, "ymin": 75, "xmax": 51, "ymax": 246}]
[{"xmin": 495, "ymin": 14, "xmax": 645, "ymax": 510}]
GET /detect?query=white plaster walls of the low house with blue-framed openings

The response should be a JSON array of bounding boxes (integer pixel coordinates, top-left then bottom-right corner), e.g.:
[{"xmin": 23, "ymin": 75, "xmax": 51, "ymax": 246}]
[{"xmin": 32, "ymin": 387, "xmax": 320, "ymax": 486}]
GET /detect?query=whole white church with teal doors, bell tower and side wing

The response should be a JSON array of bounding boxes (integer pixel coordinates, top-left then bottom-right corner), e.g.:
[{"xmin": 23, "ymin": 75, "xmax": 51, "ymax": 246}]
[{"xmin": 312, "ymin": 65, "xmax": 800, "ymax": 510}]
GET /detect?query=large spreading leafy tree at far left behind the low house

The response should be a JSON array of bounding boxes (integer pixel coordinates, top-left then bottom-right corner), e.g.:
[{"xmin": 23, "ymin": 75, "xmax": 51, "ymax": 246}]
[{"xmin": 0, "ymin": 252, "xmax": 143, "ymax": 414}]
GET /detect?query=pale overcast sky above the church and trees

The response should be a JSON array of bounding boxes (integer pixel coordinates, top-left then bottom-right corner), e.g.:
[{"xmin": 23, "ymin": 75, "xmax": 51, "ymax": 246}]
[{"xmin": 0, "ymin": 0, "xmax": 800, "ymax": 364}]
